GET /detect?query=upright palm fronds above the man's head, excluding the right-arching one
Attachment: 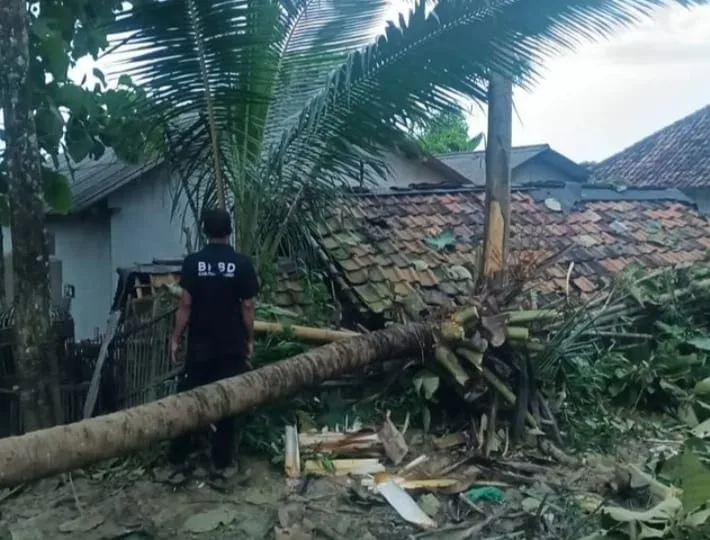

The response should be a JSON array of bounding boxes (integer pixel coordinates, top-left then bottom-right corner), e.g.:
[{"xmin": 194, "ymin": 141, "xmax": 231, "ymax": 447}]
[{"xmin": 109, "ymin": 0, "xmax": 398, "ymax": 260}]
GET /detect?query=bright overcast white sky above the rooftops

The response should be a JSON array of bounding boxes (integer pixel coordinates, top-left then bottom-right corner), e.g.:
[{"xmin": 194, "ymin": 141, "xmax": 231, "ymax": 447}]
[{"xmin": 75, "ymin": 0, "xmax": 710, "ymax": 165}]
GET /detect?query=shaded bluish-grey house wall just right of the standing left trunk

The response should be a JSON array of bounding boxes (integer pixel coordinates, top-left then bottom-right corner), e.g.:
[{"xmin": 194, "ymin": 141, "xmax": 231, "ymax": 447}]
[{"xmin": 3, "ymin": 216, "xmax": 113, "ymax": 339}]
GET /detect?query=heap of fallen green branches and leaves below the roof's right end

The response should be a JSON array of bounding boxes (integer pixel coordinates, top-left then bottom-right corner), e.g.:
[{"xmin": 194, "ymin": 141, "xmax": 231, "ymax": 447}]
[{"xmin": 539, "ymin": 263, "xmax": 710, "ymax": 448}]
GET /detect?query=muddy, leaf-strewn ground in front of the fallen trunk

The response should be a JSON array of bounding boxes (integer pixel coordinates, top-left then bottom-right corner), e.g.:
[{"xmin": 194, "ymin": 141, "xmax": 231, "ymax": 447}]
[{"xmin": 0, "ymin": 457, "xmax": 422, "ymax": 540}]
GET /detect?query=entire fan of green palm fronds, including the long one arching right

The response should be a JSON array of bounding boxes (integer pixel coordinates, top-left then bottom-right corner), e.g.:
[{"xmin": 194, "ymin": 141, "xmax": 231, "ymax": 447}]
[{"xmin": 105, "ymin": 0, "xmax": 688, "ymax": 272}]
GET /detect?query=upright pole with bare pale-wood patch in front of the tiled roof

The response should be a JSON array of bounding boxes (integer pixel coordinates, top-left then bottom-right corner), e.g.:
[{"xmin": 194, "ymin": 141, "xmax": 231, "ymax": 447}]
[{"xmin": 481, "ymin": 73, "xmax": 513, "ymax": 283}]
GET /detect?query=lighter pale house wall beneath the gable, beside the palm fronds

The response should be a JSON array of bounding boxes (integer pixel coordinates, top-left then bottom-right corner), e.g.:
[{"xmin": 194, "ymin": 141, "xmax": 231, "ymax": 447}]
[{"xmin": 108, "ymin": 168, "xmax": 194, "ymax": 287}]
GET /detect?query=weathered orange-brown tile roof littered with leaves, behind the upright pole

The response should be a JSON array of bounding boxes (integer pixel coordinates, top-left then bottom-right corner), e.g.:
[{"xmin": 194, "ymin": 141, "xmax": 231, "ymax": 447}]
[{"xmin": 317, "ymin": 189, "xmax": 710, "ymax": 316}]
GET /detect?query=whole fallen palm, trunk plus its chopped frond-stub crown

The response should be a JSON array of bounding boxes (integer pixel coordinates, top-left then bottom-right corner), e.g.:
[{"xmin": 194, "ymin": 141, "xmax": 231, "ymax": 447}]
[{"xmin": 0, "ymin": 268, "xmax": 580, "ymax": 485}]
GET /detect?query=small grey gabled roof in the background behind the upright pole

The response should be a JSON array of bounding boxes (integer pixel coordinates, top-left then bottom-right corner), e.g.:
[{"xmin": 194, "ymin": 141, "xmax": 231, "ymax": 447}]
[{"xmin": 434, "ymin": 144, "xmax": 587, "ymax": 186}]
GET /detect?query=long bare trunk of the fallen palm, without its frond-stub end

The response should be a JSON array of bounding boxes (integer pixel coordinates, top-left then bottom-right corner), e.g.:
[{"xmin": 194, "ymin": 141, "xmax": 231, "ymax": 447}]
[{"xmin": 0, "ymin": 323, "xmax": 433, "ymax": 487}]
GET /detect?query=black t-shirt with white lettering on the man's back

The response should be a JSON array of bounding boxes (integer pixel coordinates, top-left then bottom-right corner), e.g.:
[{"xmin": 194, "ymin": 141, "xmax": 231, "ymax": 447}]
[{"xmin": 180, "ymin": 244, "xmax": 259, "ymax": 356}]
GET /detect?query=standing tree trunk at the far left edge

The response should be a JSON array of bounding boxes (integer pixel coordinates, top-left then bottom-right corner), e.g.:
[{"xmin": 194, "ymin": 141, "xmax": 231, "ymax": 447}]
[{"xmin": 0, "ymin": 0, "xmax": 61, "ymax": 430}]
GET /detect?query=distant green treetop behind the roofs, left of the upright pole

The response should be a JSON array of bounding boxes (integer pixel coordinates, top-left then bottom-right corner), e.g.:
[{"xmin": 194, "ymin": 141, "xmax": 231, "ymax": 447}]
[{"xmin": 416, "ymin": 111, "xmax": 483, "ymax": 154}]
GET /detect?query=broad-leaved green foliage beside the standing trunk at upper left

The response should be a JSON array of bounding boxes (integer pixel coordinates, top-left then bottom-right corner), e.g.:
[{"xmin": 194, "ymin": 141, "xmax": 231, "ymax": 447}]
[{"xmin": 0, "ymin": 0, "xmax": 159, "ymax": 218}]
